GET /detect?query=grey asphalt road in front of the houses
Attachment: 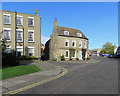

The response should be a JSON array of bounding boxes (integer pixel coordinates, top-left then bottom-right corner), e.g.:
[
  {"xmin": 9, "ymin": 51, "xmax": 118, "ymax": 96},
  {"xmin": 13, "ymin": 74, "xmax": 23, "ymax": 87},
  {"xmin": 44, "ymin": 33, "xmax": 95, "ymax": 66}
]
[{"xmin": 18, "ymin": 57, "xmax": 118, "ymax": 94}]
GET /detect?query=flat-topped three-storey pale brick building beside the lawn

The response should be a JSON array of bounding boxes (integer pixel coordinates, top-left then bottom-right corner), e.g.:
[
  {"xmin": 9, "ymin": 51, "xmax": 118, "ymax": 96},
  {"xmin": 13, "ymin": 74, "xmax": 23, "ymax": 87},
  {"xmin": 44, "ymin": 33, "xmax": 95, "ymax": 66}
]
[{"xmin": 0, "ymin": 10, "xmax": 41, "ymax": 58}]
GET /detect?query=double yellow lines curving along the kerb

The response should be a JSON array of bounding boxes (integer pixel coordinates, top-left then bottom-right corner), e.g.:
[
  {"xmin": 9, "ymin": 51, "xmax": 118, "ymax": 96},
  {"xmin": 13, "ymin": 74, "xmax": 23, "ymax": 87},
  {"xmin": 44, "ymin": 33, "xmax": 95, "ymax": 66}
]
[{"xmin": 5, "ymin": 66, "xmax": 67, "ymax": 95}]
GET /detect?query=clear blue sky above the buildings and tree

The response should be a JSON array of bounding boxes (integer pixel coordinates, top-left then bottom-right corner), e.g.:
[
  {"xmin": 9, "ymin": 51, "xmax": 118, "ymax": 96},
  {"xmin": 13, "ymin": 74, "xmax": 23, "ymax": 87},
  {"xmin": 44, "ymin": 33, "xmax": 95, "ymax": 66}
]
[{"xmin": 2, "ymin": 2, "xmax": 118, "ymax": 49}]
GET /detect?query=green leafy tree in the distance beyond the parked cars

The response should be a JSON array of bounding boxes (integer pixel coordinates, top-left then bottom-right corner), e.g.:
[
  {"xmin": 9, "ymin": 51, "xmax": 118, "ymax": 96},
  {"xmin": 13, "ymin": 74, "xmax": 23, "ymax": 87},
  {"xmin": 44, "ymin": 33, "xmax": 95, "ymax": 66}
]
[{"xmin": 102, "ymin": 42, "xmax": 115, "ymax": 54}]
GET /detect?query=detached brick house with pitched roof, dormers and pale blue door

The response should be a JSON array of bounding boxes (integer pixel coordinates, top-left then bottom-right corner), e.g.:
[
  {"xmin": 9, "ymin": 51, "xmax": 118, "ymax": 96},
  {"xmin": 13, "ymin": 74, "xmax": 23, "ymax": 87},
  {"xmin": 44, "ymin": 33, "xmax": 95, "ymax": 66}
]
[{"xmin": 49, "ymin": 19, "xmax": 88, "ymax": 60}]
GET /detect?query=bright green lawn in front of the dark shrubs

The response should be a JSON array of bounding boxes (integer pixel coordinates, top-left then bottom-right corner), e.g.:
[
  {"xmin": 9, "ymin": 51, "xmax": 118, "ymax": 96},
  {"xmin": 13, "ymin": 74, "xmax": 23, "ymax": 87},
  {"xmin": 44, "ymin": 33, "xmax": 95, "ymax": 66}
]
[{"xmin": 0, "ymin": 65, "xmax": 40, "ymax": 80}]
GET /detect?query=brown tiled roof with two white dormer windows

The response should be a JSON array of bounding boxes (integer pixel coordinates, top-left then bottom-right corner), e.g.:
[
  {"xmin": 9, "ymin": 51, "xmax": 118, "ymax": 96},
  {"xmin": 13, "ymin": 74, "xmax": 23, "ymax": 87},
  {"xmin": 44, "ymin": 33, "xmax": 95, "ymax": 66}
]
[{"xmin": 57, "ymin": 26, "xmax": 87, "ymax": 39}]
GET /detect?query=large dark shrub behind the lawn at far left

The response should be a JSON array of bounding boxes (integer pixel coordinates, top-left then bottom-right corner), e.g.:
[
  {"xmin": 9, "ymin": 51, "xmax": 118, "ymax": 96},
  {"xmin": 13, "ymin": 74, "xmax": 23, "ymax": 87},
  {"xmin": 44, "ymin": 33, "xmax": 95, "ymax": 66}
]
[{"xmin": 2, "ymin": 53, "xmax": 19, "ymax": 66}]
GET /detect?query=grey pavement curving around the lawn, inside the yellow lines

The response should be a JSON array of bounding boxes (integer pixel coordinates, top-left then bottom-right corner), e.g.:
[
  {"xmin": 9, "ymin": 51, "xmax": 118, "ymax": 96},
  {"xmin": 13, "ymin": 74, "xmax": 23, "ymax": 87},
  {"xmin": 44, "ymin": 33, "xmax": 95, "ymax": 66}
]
[{"xmin": 0, "ymin": 61, "xmax": 62, "ymax": 94}]
